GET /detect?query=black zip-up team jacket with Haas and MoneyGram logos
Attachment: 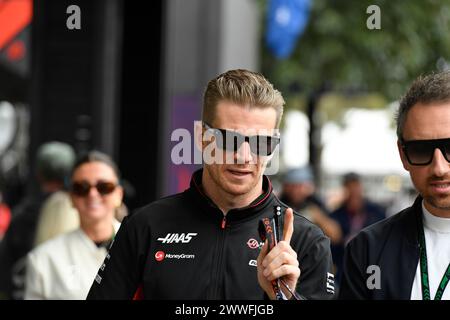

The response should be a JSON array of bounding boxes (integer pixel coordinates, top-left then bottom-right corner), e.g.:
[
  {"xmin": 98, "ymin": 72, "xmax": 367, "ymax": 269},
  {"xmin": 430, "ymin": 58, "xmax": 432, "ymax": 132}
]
[{"xmin": 87, "ymin": 170, "xmax": 334, "ymax": 300}]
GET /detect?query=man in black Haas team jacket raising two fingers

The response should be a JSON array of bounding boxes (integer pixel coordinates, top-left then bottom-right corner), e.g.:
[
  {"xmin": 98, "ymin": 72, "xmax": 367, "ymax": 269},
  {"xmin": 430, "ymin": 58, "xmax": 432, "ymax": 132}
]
[{"xmin": 88, "ymin": 70, "xmax": 334, "ymax": 300}]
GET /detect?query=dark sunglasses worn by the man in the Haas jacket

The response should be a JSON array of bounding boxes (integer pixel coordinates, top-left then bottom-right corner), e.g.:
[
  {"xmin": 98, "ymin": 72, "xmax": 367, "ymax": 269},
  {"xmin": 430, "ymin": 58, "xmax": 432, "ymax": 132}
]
[{"xmin": 203, "ymin": 122, "xmax": 280, "ymax": 156}]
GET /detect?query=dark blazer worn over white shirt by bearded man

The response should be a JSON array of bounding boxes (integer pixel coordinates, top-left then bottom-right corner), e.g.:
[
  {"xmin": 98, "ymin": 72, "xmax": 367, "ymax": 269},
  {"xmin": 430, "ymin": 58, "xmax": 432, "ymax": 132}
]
[{"xmin": 339, "ymin": 196, "xmax": 422, "ymax": 300}]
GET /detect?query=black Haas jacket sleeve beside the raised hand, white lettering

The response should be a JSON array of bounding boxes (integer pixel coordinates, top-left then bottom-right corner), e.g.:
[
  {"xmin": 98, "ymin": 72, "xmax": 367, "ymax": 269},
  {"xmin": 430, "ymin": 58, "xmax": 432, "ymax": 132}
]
[{"xmin": 296, "ymin": 227, "xmax": 334, "ymax": 300}]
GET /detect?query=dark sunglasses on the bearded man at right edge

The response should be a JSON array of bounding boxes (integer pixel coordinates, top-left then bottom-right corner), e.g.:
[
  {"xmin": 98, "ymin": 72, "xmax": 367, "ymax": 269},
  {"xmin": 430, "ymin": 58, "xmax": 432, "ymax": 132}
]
[{"xmin": 400, "ymin": 138, "xmax": 450, "ymax": 166}]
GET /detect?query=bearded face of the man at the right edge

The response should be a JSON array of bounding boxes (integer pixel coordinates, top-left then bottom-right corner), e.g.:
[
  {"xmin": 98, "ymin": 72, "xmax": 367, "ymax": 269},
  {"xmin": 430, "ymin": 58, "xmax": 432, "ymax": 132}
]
[{"xmin": 399, "ymin": 102, "xmax": 450, "ymax": 216}]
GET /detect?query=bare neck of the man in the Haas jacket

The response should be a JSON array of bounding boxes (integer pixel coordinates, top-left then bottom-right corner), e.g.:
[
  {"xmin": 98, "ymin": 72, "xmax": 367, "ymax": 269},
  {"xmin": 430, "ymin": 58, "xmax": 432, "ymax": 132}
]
[{"xmin": 202, "ymin": 170, "xmax": 264, "ymax": 215}]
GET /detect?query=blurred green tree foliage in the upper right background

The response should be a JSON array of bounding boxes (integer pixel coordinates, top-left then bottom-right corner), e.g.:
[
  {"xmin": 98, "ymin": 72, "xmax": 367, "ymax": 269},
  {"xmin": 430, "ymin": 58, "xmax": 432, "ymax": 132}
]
[{"xmin": 260, "ymin": 0, "xmax": 450, "ymax": 100}]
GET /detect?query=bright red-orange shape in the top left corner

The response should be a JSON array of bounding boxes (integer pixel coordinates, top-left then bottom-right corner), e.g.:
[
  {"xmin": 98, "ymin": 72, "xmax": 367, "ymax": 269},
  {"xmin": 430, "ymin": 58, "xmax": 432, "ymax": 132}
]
[{"xmin": 0, "ymin": 0, "xmax": 33, "ymax": 50}]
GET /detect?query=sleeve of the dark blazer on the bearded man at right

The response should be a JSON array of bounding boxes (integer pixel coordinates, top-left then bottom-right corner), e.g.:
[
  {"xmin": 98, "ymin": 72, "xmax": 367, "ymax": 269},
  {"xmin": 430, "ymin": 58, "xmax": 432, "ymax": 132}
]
[{"xmin": 339, "ymin": 233, "xmax": 371, "ymax": 300}]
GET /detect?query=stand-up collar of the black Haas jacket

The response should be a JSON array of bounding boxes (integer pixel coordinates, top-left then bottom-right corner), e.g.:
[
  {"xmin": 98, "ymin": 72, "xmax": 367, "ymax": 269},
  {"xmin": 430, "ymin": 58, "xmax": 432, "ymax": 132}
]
[{"xmin": 187, "ymin": 169, "xmax": 274, "ymax": 224}]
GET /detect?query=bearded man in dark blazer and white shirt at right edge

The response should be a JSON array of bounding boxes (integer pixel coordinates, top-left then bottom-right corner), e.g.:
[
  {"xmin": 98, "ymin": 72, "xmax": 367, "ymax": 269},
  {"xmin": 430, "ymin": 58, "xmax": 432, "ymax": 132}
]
[{"xmin": 339, "ymin": 71, "xmax": 450, "ymax": 300}]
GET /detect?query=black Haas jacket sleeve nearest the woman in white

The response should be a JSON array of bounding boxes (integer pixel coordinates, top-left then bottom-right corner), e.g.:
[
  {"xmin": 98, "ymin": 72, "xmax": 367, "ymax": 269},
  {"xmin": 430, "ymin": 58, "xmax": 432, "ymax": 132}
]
[{"xmin": 87, "ymin": 215, "xmax": 148, "ymax": 300}]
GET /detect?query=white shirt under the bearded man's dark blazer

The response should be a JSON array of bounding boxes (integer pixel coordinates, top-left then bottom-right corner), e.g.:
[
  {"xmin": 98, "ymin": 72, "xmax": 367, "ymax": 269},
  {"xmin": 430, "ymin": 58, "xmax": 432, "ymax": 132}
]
[{"xmin": 411, "ymin": 201, "xmax": 450, "ymax": 300}]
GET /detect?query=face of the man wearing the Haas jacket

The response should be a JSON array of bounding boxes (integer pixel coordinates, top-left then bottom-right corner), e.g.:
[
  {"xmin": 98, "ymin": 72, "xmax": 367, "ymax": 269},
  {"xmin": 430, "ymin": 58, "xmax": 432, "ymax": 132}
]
[{"xmin": 204, "ymin": 101, "xmax": 276, "ymax": 196}]
